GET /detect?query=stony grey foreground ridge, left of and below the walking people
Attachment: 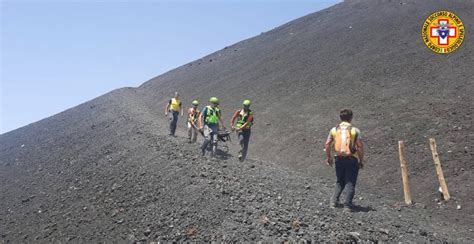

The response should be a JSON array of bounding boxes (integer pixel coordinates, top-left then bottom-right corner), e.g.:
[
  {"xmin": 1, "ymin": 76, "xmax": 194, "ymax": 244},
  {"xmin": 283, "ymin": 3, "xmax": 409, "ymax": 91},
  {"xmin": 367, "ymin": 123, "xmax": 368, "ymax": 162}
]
[{"xmin": 0, "ymin": 89, "xmax": 473, "ymax": 243}]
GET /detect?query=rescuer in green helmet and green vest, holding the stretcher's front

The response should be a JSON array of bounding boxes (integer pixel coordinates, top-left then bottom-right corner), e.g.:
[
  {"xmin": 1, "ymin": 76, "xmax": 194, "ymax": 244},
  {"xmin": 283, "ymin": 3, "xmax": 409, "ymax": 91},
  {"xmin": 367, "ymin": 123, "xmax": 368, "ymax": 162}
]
[{"xmin": 198, "ymin": 97, "xmax": 224, "ymax": 156}]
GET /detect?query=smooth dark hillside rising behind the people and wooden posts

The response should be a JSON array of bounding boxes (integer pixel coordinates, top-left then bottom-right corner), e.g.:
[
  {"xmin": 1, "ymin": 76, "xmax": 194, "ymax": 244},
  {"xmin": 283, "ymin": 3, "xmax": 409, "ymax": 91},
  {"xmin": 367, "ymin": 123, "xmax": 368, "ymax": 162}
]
[{"xmin": 135, "ymin": 1, "xmax": 474, "ymax": 225}]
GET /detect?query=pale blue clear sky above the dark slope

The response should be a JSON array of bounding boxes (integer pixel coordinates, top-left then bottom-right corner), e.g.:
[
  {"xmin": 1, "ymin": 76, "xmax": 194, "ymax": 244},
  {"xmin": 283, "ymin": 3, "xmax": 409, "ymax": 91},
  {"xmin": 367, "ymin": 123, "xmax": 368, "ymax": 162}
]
[{"xmin": 0, "ymin": 0, "xmax": 339, "ymax": 133}]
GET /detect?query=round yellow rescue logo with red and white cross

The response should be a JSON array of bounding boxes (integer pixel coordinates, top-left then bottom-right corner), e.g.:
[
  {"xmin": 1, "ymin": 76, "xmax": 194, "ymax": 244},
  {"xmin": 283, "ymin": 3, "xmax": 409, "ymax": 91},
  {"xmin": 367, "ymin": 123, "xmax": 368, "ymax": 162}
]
[{"xmin": 421, "ymin": 10, "xmax": 464, "ymax": 54}]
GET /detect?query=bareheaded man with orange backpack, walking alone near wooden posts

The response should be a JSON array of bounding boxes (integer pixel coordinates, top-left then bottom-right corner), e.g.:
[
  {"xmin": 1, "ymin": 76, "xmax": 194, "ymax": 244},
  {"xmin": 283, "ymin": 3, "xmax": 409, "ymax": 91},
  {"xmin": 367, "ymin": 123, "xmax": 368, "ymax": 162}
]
[{"xmin": 325, "ymin": 109, "xmax": 364, "ymax": 212}]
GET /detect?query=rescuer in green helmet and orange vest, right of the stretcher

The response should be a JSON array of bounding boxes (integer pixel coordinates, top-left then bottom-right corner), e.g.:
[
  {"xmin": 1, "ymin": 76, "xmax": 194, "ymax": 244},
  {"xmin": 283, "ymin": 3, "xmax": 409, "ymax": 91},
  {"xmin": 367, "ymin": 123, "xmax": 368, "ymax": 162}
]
[{"xmin": 230, "ymin": 100, "xmax": 253, "ymax": 161}]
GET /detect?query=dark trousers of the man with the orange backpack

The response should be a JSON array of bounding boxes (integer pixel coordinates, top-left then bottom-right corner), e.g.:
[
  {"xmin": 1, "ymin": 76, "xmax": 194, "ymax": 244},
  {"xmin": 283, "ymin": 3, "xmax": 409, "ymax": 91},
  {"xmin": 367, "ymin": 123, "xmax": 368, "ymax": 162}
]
[{"xmin": 331, "ymin": 157, "xmax": 359, "ymax": 206}]
